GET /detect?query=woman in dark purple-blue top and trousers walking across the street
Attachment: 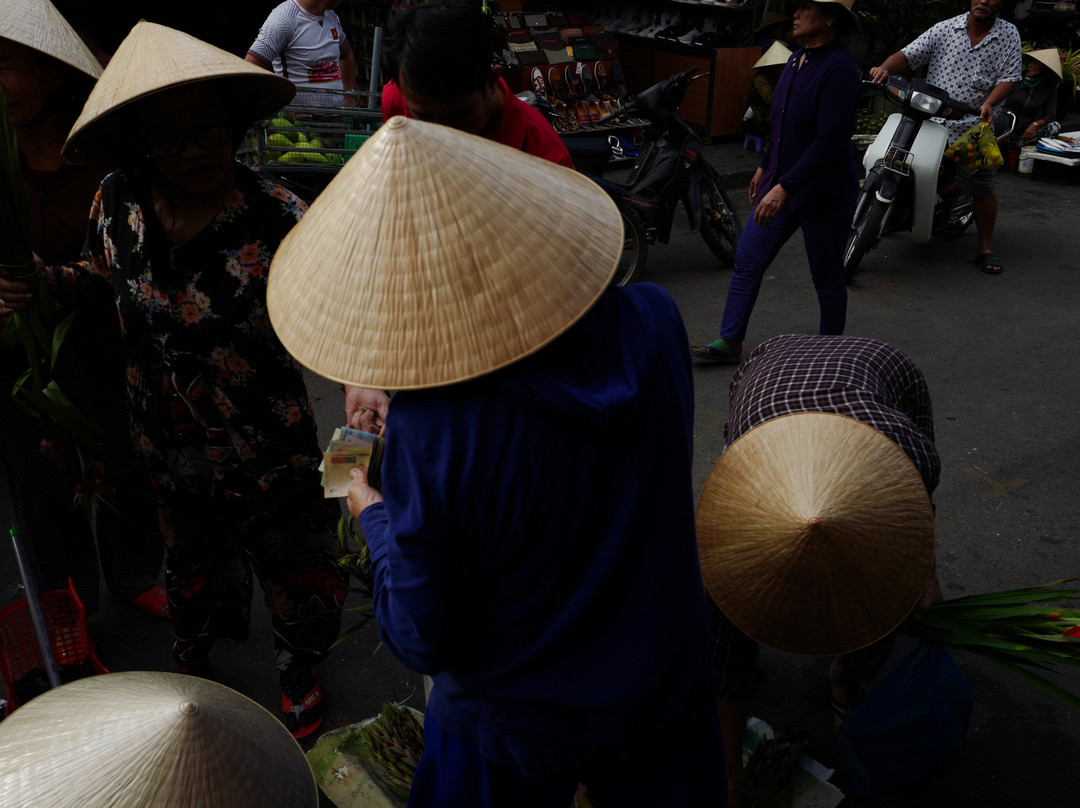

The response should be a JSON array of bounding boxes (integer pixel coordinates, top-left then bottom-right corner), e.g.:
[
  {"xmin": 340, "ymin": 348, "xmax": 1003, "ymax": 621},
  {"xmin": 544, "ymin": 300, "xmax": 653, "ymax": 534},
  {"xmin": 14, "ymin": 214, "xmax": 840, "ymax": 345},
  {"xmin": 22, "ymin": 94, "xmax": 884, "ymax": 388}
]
[{"xmin": 690, "ymin": 0, "xmax": 860, "ymax": 364}]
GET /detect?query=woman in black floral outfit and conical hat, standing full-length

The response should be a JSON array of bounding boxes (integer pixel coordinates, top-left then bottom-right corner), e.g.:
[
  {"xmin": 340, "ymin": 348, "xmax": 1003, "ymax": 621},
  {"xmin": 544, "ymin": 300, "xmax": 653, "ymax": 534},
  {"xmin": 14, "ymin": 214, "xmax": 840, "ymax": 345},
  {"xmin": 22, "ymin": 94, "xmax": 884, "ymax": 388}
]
[{"xmin": 0, "ymin": 23, "xmax": 345, "ymax": 738}]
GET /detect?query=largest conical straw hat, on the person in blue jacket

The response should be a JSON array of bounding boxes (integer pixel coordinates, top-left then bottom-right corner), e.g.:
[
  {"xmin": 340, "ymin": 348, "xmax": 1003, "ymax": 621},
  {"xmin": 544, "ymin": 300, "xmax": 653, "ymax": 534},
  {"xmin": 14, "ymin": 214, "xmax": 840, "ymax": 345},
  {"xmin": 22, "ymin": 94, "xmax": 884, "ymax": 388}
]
[{"xmin": 267, "ymin": 118, "xmax": 622, "ymax": 390}]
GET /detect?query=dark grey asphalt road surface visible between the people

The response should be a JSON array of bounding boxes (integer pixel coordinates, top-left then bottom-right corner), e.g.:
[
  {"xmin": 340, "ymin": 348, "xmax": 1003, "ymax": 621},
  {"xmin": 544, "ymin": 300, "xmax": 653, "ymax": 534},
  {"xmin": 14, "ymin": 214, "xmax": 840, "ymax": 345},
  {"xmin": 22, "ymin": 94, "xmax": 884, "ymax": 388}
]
[{"xmin": 0, "ymin": 165, "xmax": 1080, "ymax": 808}]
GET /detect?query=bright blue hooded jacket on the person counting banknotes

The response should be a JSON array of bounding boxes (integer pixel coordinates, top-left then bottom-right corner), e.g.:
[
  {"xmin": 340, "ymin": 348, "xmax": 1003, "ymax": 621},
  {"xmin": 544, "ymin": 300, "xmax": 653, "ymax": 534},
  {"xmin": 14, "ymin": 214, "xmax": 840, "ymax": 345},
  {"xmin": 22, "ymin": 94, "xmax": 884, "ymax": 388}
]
[{"xmin": 361, "ymin": 284, "xmax": 715, "ymax": 777}]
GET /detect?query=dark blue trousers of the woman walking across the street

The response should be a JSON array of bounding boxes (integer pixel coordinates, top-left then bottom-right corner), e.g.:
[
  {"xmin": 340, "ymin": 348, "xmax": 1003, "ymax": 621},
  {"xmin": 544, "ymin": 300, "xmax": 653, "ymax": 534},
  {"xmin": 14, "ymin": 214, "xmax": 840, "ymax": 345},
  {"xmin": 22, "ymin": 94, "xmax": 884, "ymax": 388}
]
[{"xmin": 720, "ymin": 205, "xmax": 855, "ymax": 342}]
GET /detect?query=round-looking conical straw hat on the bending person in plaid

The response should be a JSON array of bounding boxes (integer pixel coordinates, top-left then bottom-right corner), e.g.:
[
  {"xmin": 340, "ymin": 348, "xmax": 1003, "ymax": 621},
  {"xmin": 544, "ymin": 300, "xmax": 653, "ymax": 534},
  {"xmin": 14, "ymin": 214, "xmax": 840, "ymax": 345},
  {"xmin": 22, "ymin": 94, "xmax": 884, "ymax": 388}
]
[{"xmin": 697, "ymin": 413, "xmax": 934, "ymax": 656}]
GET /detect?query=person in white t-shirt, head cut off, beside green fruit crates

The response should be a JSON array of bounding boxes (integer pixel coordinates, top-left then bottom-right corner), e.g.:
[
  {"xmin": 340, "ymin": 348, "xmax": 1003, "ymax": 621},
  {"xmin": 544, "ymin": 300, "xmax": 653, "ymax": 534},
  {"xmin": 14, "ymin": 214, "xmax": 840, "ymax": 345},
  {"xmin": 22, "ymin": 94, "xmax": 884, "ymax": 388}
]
[{"xmin": 244, "ymin": 0, "xmax": 356, "ymax": 107}]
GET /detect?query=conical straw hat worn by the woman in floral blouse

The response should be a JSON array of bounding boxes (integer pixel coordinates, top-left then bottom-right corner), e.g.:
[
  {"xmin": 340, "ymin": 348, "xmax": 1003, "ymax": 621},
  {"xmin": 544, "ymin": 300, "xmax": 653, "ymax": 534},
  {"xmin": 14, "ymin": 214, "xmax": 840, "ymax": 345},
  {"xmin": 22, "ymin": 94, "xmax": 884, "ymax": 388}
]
[{"xmin": 64, "ymin": 21, "xmax": 296, "ymax": 163}]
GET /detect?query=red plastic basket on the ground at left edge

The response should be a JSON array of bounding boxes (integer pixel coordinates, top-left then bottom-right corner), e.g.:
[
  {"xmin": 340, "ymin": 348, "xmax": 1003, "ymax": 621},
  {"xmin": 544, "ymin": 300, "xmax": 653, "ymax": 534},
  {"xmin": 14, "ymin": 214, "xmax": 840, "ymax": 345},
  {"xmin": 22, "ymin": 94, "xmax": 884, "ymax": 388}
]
[{"xmin": 0, "ymin": 578, "xmax": 108, "ymax": 715}]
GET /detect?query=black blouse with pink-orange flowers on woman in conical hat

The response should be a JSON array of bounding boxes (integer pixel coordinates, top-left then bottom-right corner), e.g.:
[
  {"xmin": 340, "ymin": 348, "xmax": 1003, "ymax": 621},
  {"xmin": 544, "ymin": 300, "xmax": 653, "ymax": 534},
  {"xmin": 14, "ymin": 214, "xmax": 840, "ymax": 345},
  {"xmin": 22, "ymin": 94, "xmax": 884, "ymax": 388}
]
[{"xmin": 63, "ymin": 165, "xmax": 321, "ymax": 510}]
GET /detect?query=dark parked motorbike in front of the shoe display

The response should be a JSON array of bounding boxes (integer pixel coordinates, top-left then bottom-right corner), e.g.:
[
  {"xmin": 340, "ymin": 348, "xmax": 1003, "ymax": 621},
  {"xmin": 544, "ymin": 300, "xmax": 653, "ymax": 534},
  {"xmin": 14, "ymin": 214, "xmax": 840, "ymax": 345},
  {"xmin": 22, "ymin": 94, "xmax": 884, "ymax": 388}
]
[{"xmin": 518, "ymin": 67, "xmax": 742, "ymax": 285}]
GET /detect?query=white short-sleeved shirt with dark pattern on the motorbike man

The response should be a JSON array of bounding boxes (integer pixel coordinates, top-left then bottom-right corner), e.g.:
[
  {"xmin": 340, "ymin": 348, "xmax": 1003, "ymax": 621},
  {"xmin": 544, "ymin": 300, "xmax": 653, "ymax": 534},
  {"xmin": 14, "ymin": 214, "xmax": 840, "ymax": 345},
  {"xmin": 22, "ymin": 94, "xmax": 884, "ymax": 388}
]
[{"xmin": 902, "ymin": 12, "xmax": 1023, "ymax": 143}]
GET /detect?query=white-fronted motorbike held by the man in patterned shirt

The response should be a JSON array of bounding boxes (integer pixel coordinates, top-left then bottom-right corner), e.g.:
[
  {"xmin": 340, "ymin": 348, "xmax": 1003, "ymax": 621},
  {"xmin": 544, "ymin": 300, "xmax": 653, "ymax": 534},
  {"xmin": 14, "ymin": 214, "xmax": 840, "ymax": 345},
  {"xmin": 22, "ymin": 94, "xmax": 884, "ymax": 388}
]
[{"xmin": 843, "ymin": 76, "xmax": 1015, "ymax": 281}]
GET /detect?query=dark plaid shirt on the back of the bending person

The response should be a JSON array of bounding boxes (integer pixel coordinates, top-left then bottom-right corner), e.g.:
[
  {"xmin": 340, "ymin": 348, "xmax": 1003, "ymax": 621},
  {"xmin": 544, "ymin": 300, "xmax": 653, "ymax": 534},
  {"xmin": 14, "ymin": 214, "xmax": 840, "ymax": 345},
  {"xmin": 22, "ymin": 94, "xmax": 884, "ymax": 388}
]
[{"xmin": 724, "ymin": 335, "xmax": 941, "ymax": 494}]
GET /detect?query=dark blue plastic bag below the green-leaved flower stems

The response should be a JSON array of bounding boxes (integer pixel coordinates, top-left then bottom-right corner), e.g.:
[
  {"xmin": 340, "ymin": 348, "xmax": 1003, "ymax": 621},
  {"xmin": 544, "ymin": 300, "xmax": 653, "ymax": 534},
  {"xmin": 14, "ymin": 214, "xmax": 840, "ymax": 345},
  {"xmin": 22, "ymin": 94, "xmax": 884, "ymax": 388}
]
[{"xmin": 838, "ymin": 646, "xmax": 975, "ymax": 796}]
